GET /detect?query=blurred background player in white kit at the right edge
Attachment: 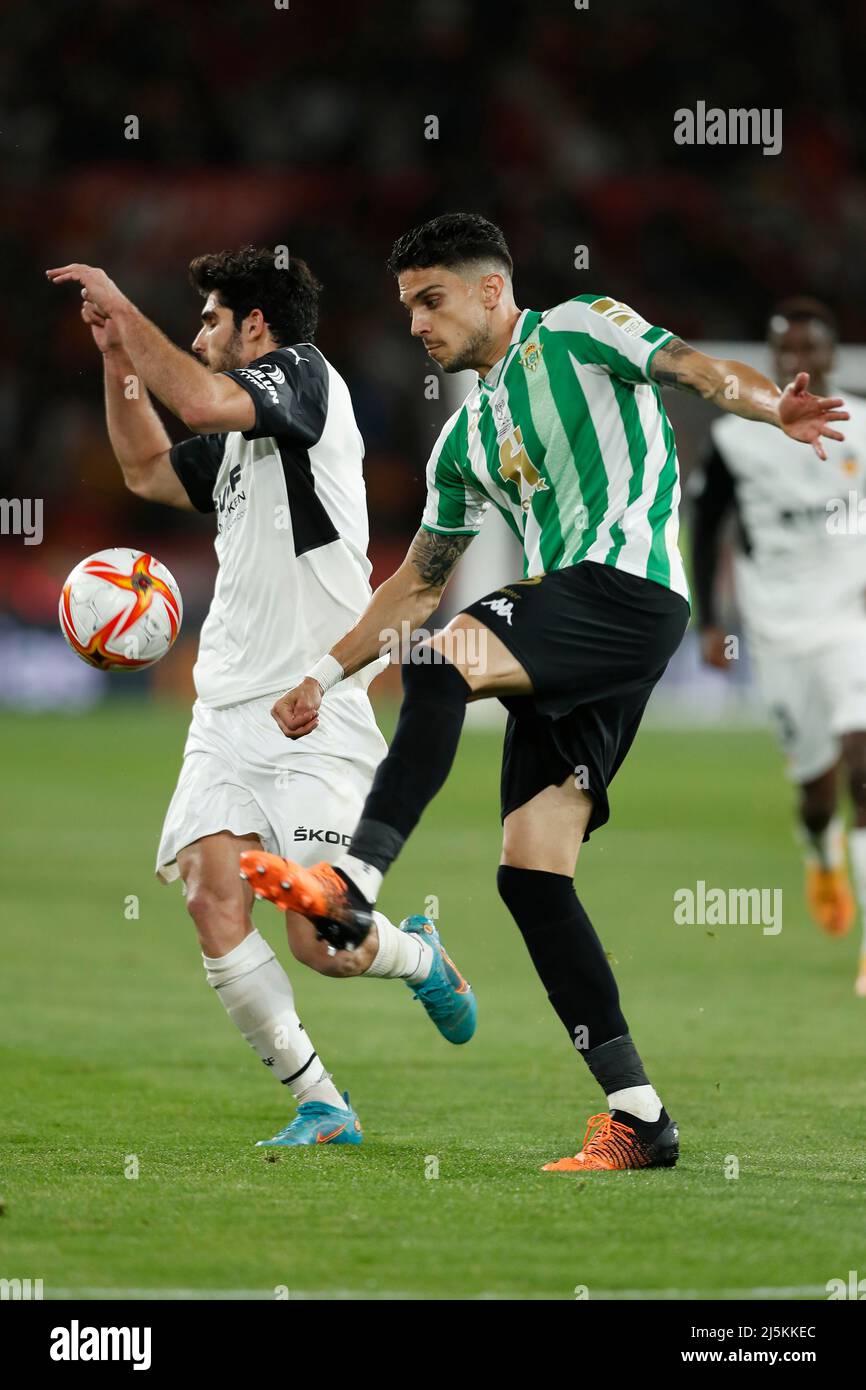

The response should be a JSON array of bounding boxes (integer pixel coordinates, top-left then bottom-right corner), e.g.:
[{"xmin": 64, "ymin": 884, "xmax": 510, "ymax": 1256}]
[{"xmin": 692, "ymin": 297, "xmax": 866, "ymax": 997}]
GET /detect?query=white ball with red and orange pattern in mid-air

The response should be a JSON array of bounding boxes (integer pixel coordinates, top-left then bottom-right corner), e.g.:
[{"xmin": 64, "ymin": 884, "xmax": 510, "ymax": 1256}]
[{"xmin": 58, "ymin": 546, "xmax": 183, "ymax": 671}]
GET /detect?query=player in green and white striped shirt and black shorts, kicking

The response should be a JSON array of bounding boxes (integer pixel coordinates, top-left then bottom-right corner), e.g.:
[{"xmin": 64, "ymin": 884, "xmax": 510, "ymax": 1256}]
[{"xmin": 243, "ymin": 213, "xmax": 848, "ymax": 1172}]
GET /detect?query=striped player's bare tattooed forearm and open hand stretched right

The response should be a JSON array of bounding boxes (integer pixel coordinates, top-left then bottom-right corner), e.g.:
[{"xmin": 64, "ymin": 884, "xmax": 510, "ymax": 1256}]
[{"xmin": 649, "ymin": 338, "xmax": 851, "ymax": 459}]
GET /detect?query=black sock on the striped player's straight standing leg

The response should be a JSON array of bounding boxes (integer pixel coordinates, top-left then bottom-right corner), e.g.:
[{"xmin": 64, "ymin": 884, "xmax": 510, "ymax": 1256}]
[{"xmin": 496, "ymin": 865, "xmax": 628, "ymax": 1045}]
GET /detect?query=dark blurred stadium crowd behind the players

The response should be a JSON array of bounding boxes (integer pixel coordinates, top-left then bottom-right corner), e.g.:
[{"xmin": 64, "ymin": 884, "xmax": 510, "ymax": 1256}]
[{"xmin": 0, "ymin": 0, "xmax": 866, "ymax": 706}]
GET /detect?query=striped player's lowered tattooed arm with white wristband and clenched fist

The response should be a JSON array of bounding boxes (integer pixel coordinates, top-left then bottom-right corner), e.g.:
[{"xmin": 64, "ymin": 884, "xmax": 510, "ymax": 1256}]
[{"xmin": 271, "ymin": 527, "xmax": 474, "ymax": 738}]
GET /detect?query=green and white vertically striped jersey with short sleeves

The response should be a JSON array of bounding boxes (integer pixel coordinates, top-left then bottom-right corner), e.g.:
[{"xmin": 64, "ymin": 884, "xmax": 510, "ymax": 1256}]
[{"xmin": 421, "ymin": 295, "xmax": 688, "ymax": 598}]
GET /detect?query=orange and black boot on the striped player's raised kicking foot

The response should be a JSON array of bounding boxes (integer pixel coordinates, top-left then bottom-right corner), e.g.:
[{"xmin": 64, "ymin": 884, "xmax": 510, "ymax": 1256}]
[{"xmin": 240, "ymin": 849, "xmax": 373, "ymax": 949}]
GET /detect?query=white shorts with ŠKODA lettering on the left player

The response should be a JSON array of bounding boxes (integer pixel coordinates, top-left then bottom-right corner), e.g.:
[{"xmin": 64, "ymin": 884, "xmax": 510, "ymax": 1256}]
[{"xmin": 156, "ymin": 689, "xmax": 388, "ymax": 883}]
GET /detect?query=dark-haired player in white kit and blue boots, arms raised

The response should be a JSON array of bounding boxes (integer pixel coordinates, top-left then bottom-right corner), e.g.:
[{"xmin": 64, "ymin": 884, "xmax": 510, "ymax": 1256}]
[{"xmin": 47, "ymin": 246, "xmax": 475, "ymax": 1147}]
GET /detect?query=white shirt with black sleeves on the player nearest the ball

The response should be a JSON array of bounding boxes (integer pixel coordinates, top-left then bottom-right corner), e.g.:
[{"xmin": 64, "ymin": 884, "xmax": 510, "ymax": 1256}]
[{"xmin": 171, "ymin": 343, "xmax": 384, "ymax": 709}]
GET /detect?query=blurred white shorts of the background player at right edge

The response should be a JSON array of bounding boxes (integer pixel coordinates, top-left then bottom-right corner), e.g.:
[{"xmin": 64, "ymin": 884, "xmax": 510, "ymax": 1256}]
[{"xmin": 751, "ymin": 625, "xmax": 866, "ymax": 783}]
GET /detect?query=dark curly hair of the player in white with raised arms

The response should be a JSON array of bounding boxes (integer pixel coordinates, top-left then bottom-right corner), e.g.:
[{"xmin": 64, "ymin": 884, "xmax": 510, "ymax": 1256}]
[{"xmin": 189, "ymin": 246, "xmax": 321, "ymax": 346}]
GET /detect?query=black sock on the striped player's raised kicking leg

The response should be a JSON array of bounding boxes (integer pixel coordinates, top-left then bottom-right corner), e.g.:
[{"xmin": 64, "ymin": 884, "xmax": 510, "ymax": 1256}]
[{"xmin": 349, "ymin": 662, "xmax": 470, "ymax": 873}]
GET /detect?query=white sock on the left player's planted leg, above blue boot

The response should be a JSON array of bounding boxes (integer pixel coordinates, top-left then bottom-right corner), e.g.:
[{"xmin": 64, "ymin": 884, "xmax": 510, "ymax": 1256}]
[{"xmin": 202, "ymin": 930, "xmax": 345, "ymax": 1109}]
